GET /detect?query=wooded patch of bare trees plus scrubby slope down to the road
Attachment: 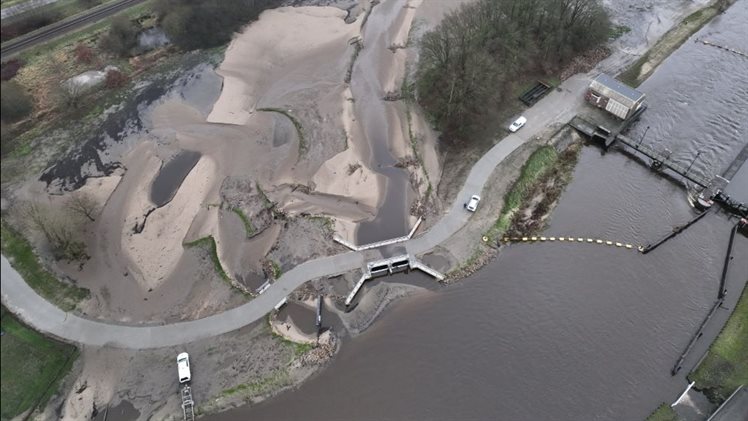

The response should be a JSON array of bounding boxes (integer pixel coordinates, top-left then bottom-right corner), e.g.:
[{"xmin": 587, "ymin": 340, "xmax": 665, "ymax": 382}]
[{"xmin": 415, "ymin": 0, "xmax": 615, "ymax": 205}]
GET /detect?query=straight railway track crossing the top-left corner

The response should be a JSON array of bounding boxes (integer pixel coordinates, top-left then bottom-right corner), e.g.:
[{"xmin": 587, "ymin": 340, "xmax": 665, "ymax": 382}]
[{"xmin": 0, "ymin": 0, "xmax": 145, "ymax": 60}]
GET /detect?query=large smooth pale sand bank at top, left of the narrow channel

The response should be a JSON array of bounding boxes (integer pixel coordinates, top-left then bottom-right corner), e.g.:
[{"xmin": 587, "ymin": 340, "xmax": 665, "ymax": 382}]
[{"xmin": 208, "ymin": 7, "xmax": 357, "ymax": 124}]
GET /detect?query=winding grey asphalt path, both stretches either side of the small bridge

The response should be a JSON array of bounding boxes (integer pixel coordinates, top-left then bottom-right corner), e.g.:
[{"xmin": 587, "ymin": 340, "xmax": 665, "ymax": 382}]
[{"xmin": 0, "ymin": 74, "xmax": 590, "ymax": 349}]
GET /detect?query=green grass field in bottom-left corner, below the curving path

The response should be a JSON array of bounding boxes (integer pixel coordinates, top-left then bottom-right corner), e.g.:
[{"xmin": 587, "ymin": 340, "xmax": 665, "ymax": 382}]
[{"xmin": 0, "ymin": 307, "xmax": 78, "ymax": 420}]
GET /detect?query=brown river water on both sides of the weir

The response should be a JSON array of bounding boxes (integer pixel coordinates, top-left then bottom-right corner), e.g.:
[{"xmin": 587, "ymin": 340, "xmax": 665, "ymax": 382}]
[{"xmin": 206, "ymin": 0, "xmax": 748, "ymax": 421}]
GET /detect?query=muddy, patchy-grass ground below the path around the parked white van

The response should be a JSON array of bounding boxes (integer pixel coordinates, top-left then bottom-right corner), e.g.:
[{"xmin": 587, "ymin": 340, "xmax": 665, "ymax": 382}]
[{"xmin": 35, "ymin": 320, "xmax": 338, "ymax": 420}]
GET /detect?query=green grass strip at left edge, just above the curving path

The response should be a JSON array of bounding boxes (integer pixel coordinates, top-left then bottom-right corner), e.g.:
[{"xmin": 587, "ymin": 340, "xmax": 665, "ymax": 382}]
[{"xmin": 0, "ymin": 221, "xmax": 90, "ymax": 311}]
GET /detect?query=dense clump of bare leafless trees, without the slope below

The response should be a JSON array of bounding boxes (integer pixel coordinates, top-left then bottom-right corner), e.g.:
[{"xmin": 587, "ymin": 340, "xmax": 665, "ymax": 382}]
[{"xmin": 416, "ymin": 0, "xmax": 610, "ymax": 141}]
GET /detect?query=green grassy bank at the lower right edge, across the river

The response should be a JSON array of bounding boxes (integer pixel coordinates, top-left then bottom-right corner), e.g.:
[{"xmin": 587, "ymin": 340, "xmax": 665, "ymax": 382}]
[{"xmin": 688, "ymin": 287, "xmax": 748, "ymax": 404}]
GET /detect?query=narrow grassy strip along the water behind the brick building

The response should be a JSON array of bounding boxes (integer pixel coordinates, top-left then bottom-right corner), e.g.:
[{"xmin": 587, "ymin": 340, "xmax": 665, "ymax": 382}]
[{"xmin": 618, "ymin": 0, "xmax": 735, "ymax": 87}]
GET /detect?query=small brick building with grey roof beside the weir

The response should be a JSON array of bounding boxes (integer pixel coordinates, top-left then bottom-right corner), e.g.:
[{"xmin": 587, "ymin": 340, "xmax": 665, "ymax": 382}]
[{"xmin": 585, "ymin": 73, "xmax": 645, "ymax": 120}]
